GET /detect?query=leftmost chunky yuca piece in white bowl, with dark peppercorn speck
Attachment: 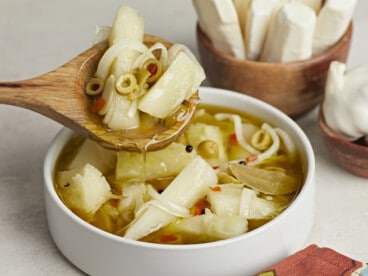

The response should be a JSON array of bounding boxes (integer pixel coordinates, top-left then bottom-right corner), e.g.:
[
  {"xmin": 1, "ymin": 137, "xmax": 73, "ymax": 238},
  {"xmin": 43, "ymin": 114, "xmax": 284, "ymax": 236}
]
[{"xmin": 57, "ymin": 164, "xmax": 112, "ymax": 216}]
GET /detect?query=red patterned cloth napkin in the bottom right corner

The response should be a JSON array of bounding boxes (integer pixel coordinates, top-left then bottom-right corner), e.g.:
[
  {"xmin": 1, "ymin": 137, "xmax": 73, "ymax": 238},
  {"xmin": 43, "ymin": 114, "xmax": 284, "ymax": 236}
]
[{"xmin": 257, "ymin": 244, "xmax": 368, "ymax": 276}]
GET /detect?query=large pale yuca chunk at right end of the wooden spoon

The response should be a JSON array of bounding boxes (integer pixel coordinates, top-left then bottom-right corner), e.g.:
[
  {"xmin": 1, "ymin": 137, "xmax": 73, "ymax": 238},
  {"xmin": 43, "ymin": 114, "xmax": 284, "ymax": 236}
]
[{"xmin": 138, "ymin": 51, "xmax": 205, "ymax": 118}]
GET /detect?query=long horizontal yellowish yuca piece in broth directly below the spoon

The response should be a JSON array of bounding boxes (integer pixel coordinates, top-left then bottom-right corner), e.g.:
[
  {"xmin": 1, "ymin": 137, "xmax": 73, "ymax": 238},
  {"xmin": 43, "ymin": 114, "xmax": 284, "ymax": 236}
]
[{"xmin": 115, "ymin": 142, "xmax": 197, "ymax": 181}]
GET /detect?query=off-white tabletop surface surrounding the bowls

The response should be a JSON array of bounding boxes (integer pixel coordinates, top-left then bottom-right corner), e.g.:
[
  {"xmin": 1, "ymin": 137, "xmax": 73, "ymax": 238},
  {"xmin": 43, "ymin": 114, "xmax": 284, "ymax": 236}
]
[{"xmin": 0, "ymin": 0, "xmax": 368, "ymax": 275}]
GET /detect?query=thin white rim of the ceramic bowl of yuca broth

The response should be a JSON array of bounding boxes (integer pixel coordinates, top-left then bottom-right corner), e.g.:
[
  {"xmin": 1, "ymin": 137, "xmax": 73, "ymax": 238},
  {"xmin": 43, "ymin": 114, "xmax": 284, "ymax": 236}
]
[{"xmin": 43, "ymin": 86, "xmax": 315, "ymax": 251}]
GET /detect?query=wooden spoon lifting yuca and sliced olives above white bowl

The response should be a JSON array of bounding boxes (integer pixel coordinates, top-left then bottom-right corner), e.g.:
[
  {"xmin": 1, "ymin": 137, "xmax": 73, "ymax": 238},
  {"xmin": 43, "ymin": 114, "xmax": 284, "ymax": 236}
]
[{"xmin": 0, "ymin": 35, "xmax": 199, "ymax": 151}]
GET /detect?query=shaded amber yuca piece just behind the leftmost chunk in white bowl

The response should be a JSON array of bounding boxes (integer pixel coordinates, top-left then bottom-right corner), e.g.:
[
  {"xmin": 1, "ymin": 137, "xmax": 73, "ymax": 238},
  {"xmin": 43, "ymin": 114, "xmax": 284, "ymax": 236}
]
[{"xmin": 67, "ymin": 139, "xmax": 116, "ymax": 174}]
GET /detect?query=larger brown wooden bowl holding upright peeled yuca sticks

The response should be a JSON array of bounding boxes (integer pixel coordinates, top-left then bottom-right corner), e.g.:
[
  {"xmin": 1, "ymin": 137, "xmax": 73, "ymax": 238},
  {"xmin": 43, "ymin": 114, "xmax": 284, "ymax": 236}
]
[{"xmin": 196, "ymin": 23, "xmax": 353, "ymax": 117}]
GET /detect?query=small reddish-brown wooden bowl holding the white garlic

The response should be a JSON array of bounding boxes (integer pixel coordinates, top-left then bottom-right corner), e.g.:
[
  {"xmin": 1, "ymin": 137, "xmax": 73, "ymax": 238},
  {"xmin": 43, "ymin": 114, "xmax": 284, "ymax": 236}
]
[{"xmin": 318, "ymin": 108, "xmax": 368, "ymax": 178}]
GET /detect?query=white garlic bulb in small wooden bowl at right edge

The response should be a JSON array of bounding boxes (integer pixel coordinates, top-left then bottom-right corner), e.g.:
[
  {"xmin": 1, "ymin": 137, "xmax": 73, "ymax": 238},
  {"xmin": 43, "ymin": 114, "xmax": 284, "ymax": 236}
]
[{"xmin": 322, "ymin": 61, "xmax": 368, "ymax": 141}]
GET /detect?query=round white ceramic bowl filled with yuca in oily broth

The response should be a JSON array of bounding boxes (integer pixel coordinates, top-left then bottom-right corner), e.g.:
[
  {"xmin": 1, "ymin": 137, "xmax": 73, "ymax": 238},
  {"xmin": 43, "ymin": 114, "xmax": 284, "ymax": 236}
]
[{"xmin": 44, "ymin": 87, "xmax": 315, "ymax": 276}]
